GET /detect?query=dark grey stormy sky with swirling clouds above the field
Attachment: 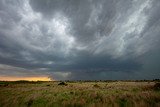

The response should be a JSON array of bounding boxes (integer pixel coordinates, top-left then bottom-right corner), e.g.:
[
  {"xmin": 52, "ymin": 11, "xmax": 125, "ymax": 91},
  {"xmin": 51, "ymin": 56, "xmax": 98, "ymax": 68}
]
[{"xmin": 0, "ymin": 0, "xmax": 160, "ymax": 80}]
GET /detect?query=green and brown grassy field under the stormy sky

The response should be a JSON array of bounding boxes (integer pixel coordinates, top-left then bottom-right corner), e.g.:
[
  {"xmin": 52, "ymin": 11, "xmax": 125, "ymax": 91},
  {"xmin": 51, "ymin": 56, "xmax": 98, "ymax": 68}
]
[{"xmin": 0, "ymin": 81, "xmax": 160, "ymax": 107}]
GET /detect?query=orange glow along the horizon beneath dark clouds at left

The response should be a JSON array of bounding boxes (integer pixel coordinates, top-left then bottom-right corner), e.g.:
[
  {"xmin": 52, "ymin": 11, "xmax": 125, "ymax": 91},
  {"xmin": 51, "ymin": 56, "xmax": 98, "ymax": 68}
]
[{"xmin": 0, "ymin": 76, "xmax": 51, "ymax": 81}]
